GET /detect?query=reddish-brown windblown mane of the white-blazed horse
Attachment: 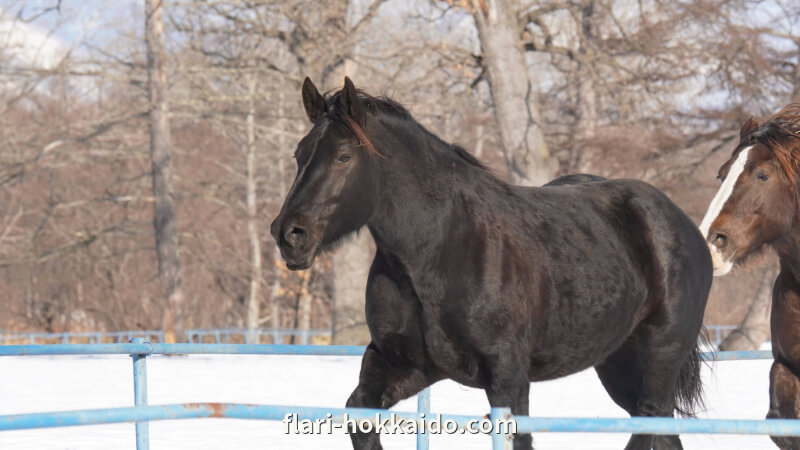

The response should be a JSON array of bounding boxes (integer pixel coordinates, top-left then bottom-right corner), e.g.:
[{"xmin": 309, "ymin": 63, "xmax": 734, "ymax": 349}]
[{"xmin": 742, "ymin": 103, "xmax": 800, "ymax": 181}]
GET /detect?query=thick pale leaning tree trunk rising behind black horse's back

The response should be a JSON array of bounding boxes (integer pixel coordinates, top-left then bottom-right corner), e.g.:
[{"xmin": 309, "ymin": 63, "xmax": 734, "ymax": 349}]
[{"xmin": 472, "ymin": 0, "xmax": 554, "ymax": 186}]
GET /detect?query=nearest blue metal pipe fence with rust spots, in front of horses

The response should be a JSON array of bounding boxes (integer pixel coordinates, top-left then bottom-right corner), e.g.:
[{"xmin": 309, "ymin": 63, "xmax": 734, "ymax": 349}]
[{"xmin": 0, "ymin": 338, "xmax": 788, "ymax": 450}]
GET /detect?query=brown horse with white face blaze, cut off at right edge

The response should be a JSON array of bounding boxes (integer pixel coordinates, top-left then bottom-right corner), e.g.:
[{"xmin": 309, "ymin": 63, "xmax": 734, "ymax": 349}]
[{"xmin": 700, "ymin": 103, "xmax": 800, "ymax": 450}]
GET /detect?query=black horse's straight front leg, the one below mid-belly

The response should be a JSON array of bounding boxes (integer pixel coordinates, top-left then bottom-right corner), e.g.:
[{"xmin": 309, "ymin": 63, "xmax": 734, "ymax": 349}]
[{"xmin": 486, "ymin": 360, "xmax": 533, "ymax": 450}]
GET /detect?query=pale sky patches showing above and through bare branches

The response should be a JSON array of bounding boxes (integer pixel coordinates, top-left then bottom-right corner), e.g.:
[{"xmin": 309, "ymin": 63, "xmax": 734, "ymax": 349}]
[{"xmin": 0, "ymin": 0, "xmax": 800, "ymax": 109}]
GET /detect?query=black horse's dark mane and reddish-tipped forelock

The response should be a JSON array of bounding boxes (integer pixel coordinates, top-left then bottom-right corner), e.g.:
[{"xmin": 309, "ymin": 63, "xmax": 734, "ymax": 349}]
[{"xmin": 325, "ymin": 90, "xmax": 491, "ymax": 172}]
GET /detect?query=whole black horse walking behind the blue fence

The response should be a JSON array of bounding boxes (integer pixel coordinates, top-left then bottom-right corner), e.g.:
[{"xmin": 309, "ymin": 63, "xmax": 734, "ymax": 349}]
[{"xmin": 271, "ymin": 78, "xmax": 712, "ymax": 449}]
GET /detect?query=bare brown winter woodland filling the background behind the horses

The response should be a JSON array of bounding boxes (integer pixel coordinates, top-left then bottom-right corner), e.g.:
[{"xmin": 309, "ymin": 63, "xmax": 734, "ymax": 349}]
[{"xmin": 0, "ymin": 0, "xmax": 800, "ymax": 342}]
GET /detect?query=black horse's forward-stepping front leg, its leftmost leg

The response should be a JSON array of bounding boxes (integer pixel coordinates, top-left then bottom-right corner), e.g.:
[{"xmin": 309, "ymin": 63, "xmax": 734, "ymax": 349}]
[{"xmin": 347, "ymin": 344, "xmax": 438, "ymax": 450}]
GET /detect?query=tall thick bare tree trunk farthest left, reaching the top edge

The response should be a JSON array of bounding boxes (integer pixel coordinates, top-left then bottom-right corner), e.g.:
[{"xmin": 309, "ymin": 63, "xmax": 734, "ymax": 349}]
[{"xmin": 145, "ymin": 0, "xmax": 184, "ymax": 342}]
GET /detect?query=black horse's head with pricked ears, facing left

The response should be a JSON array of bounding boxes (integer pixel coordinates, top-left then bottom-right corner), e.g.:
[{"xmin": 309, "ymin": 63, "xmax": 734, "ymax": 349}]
[{"xmin": 270, "ymin": 78, "xmax": 381, "ymax": 270}]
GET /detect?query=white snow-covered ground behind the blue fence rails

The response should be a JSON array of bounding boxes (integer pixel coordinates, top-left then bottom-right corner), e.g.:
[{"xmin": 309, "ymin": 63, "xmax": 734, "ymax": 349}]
[{"xmin": 0, "ymin": 355, "xmax": 776, "ymax": 450}]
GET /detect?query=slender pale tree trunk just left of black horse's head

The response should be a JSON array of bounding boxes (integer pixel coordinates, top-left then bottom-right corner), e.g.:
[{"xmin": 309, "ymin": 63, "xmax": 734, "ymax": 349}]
[{"xmin": 246, "ymin": 75, "xmax": 261, "ymax": 344}]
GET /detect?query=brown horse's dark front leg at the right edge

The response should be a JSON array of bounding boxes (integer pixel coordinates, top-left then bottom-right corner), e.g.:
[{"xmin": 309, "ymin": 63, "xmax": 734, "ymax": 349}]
[{"xmin": 767, "ymin": 361, "xmax": 800, "ymax": 450}]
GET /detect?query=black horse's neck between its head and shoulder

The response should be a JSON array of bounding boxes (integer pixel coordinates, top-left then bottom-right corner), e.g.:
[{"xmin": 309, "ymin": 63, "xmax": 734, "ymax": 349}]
[{"xmin": 367, "ymin": 116, "xmax": 507, "ymax": 267}]
